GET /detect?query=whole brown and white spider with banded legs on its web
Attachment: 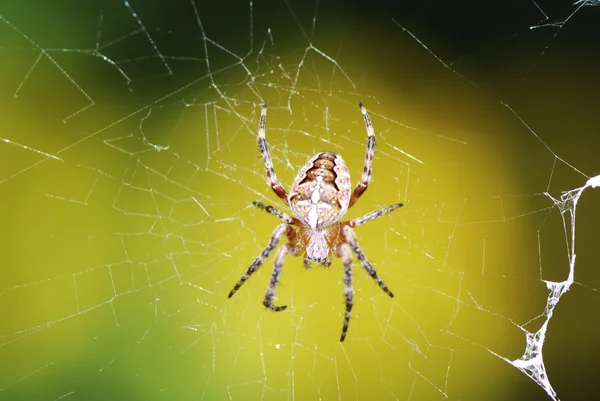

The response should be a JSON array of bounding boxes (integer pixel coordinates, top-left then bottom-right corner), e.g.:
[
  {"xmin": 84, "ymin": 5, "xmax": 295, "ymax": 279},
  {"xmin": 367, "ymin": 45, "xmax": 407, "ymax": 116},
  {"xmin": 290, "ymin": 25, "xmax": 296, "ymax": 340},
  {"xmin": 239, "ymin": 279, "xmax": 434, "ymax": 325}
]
[{"xmin": 229, "ymin": 103, "xmax": 402, "ymax": 341}]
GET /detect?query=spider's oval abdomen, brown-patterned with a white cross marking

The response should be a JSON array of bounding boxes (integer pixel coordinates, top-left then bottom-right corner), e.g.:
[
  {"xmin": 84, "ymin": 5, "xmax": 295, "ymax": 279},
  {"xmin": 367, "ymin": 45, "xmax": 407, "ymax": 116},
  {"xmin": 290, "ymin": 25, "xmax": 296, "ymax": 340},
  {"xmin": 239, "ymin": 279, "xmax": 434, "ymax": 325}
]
[{"xmin": 288, "ymin": 152, "xmax": 350, "ymax": 229}]
